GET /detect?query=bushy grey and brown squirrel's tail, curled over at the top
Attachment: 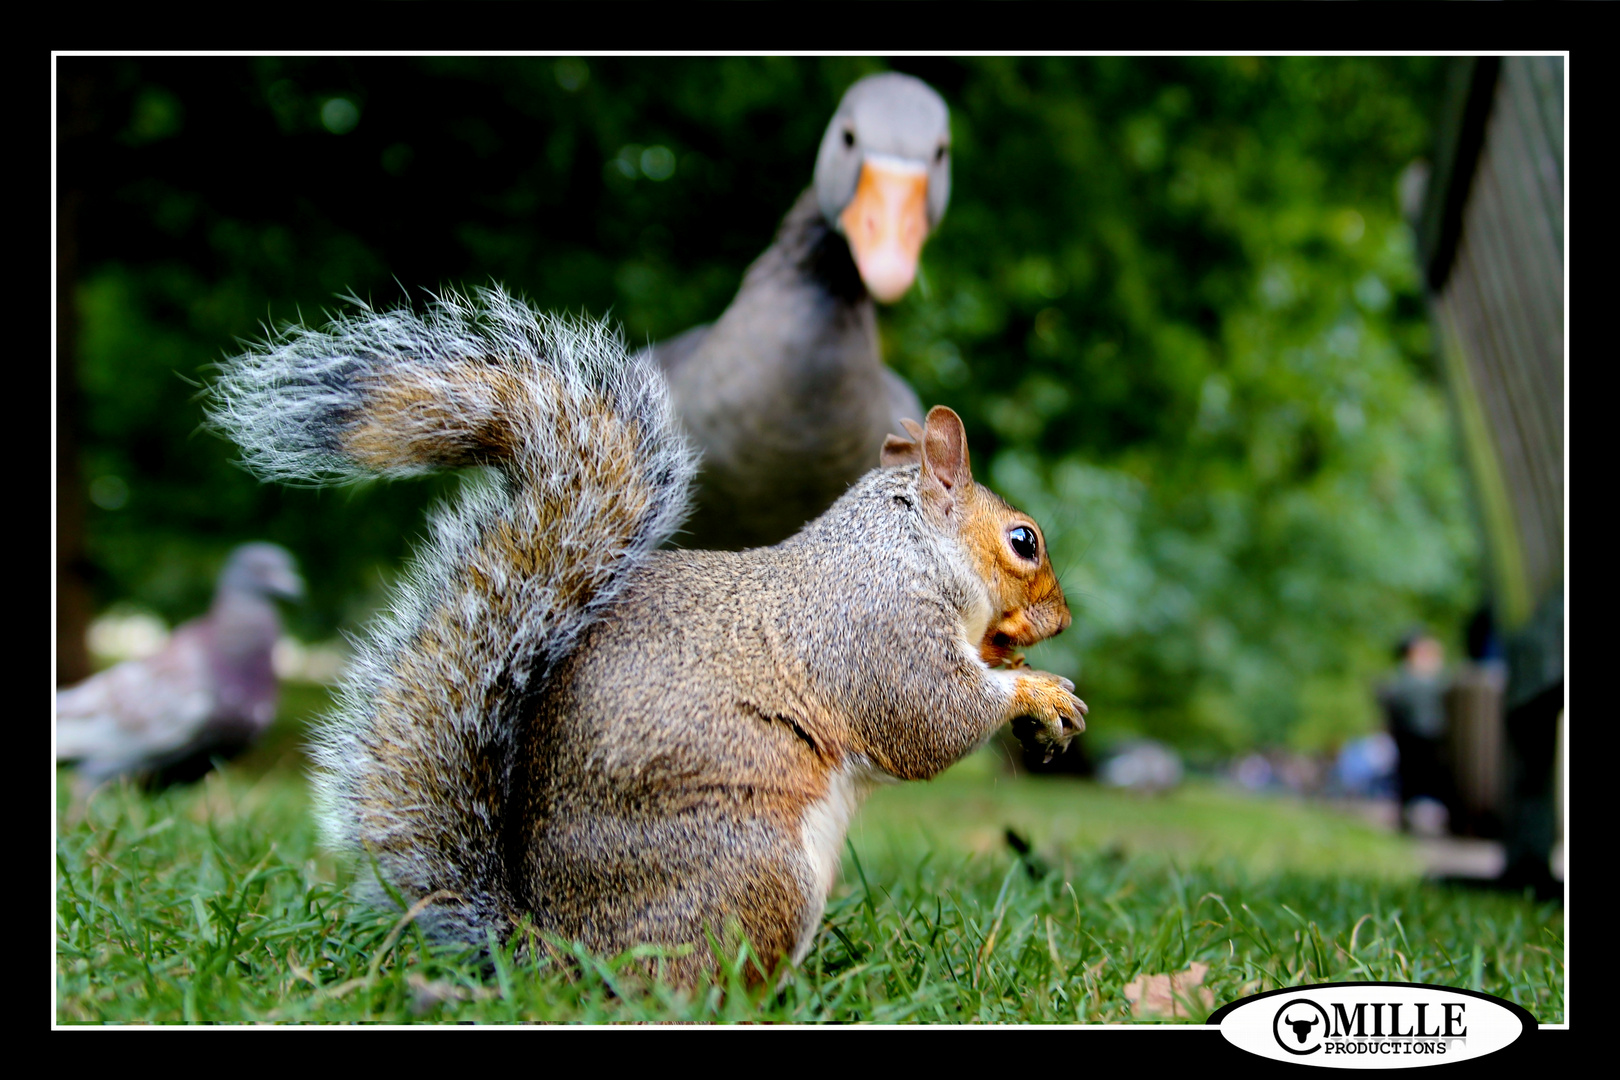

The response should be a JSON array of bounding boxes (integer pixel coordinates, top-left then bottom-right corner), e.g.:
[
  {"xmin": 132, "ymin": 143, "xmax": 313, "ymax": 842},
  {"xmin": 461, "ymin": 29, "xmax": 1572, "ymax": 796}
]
[{"xmin": 209, "ymin": 288, "xmax": 695, "ymax": 944}]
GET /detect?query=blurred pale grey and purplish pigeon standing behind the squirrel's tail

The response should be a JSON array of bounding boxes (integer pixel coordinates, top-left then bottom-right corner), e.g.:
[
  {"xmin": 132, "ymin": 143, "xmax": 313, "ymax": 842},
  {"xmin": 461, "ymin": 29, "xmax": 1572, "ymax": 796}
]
[{"xmin": 57, "ymin": 544, "xmax": 303, "ymax": 785}]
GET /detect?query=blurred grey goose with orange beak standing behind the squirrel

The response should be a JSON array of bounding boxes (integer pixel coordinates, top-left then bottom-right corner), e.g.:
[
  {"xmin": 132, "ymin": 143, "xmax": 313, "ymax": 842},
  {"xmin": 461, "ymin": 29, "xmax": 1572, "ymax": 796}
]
[{"xmin": 650, "ymin": 73, "xmax": 951, "ymax": 549}]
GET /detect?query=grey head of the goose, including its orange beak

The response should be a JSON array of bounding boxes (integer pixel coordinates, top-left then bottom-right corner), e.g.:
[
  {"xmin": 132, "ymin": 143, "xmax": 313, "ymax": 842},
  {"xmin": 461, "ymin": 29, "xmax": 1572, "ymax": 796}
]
[{"xmin": 815, "ymin": 71, "xmax": 951, "ymax": 303}]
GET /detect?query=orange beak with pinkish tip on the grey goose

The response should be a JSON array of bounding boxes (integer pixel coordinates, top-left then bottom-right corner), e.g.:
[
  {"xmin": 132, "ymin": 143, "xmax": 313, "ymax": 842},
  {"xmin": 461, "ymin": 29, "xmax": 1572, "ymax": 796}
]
[{"xmin": 838, "ymin": 159, "xmax": 928, "ymax": 304}]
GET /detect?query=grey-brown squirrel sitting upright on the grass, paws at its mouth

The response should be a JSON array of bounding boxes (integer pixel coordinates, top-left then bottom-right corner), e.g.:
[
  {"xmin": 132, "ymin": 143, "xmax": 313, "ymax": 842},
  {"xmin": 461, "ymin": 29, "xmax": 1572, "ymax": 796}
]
[{"xmin": 207, "ymin": 287, "xmax": 1087, "ymax": 984}]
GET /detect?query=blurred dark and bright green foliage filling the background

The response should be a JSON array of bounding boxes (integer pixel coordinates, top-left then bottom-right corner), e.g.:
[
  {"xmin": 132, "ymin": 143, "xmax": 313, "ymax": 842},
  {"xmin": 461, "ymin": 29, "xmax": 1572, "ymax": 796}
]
[{"xmin": 57, "ymin": 57, "xmax": 1479, "ymax": 751}]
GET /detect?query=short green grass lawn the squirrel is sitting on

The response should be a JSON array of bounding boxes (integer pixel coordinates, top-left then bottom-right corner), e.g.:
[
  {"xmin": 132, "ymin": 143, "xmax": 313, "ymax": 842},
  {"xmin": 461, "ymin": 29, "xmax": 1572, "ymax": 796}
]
[{"xmin": 57, "ymin": 688, "xmax": 1563, "ymax": 1023}]
